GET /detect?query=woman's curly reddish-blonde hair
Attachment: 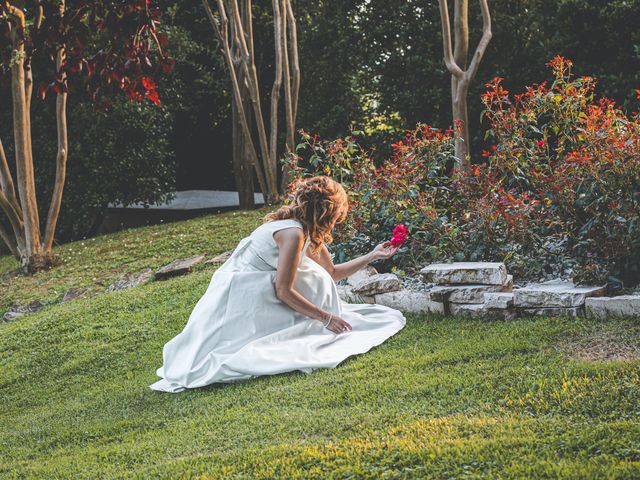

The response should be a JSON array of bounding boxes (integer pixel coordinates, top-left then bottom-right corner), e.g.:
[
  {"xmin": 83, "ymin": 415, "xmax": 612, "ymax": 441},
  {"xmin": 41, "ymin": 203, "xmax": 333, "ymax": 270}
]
[{"xmin": 264, "ymin": 175, "xmax": 349, "ymax": 254}]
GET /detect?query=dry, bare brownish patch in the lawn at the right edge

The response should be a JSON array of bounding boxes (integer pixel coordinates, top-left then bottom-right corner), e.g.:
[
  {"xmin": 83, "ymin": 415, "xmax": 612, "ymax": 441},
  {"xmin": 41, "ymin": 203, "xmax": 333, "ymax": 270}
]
[{"xmin": 554, "ymin": 329, "xmax": 640, "ymax": 362}]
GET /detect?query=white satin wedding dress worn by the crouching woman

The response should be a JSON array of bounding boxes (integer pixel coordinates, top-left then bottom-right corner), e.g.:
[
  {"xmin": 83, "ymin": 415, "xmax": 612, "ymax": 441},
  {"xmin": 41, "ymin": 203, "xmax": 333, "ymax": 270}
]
[{"xmin": 150, "ymin": 220, "xmax": 405, "ymax": 393}]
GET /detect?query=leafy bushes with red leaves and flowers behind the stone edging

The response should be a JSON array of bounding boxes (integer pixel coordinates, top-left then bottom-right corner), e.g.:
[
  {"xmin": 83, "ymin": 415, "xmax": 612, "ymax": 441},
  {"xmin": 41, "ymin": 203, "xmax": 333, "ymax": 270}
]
[{"xmin": 287, "ymin": 57, "xmax": 640, "ymax": 291}]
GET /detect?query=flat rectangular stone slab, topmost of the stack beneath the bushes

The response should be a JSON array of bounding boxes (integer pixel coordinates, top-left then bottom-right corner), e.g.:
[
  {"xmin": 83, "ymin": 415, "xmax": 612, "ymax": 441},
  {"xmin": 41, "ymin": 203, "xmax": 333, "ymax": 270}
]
[{"xmin": 420, "ymin": 262, "xmax": 507, "ymax": 285}]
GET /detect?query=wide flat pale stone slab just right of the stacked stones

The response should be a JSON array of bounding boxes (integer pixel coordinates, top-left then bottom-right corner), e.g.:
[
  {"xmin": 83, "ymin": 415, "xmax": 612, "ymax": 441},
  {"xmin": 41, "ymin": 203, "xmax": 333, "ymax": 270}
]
[{"xmin": 513, "ymin": 281, "xmax": 605, "ymax": 308}]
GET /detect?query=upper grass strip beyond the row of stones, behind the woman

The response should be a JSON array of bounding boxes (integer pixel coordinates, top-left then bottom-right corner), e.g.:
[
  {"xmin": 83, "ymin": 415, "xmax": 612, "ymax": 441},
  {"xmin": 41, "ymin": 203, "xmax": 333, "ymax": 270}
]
[{"xmin": 0, "ymin": 208, "xmax": 269, "ymax": 313}]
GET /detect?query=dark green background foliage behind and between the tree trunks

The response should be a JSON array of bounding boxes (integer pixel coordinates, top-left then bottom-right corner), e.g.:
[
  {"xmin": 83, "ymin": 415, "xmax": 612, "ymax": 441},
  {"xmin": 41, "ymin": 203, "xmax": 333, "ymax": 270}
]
[{"xmin": 0, "ymin": 0, "xmax": 640, "ymax": 251}]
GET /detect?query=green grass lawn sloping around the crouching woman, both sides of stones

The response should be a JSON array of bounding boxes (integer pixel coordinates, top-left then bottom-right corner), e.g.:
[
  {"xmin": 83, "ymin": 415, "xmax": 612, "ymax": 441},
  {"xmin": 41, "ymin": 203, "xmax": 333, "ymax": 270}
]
[{"xmin": 0, "ymin": 211, "xmax": 640, "ymax": 479}]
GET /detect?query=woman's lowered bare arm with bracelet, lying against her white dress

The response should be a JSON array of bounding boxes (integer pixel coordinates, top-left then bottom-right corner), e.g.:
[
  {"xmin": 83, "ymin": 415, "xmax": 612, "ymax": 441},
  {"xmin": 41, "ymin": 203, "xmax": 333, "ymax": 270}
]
[{"xmin": 273, "ymin": 227, "xmax": 351, "ymax": 333}]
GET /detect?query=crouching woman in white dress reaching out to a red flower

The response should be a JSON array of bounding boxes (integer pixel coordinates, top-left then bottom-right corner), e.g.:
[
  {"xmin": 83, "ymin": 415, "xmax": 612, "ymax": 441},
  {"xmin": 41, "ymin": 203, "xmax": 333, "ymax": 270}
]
[{"xmin": 151, "ymin": 176, "xmax": 405, "ymax": 393}]
